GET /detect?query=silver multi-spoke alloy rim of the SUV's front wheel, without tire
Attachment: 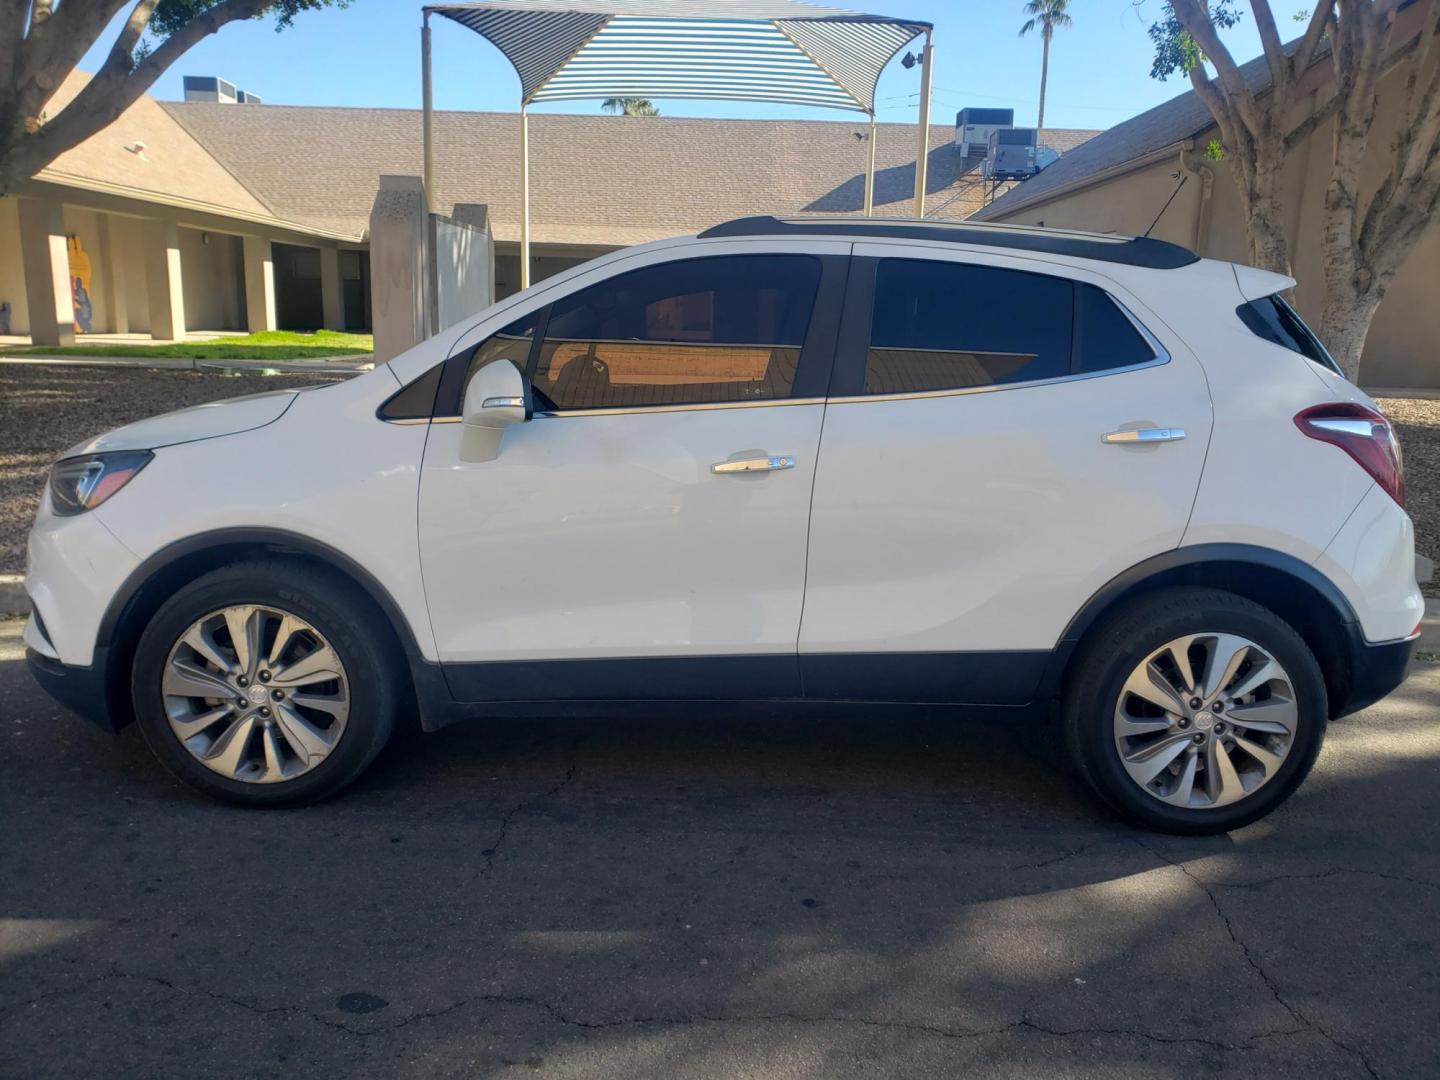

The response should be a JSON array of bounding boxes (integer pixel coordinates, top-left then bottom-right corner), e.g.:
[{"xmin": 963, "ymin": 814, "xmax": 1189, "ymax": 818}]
[{"xmin": 160, "ymin": 605, "xmax": 350, "ymax": 783}]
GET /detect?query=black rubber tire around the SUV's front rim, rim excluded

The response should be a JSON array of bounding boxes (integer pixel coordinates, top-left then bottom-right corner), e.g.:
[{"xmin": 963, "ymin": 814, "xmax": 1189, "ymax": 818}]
[{"xmin": 131, "ymin": 559, "xmax": 408, "ymax": 806}]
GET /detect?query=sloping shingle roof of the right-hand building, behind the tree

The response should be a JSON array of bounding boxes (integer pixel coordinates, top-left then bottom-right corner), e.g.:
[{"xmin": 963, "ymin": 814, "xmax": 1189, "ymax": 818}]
[{"xmin": 975, "ymin": 40, "xmax": 1296, "ymax": 220}]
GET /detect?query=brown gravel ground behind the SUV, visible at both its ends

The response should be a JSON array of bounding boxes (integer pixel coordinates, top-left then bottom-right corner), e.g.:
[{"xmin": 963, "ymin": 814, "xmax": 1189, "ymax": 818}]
[{"xmin": 0, "ymin": 364, "xmax": 1440, "ymax": 584}]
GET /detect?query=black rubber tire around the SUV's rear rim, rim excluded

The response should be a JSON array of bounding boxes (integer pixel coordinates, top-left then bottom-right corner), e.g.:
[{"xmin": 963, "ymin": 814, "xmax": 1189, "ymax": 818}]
[{"xmin": 1061, "ymin": 588, "xmax": 1329, "ymax": 835}]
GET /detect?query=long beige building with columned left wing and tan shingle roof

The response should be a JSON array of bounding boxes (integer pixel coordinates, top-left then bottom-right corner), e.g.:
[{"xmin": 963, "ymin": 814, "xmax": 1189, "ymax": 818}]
[{"xmin": 0, "ymin": 76, "xmax": 1096, "ymax": 344}]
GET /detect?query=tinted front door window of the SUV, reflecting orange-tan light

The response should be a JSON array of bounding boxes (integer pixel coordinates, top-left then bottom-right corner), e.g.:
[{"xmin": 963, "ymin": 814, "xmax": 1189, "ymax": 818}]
[{"xmin": 534, "ymin": 255, "xmax": 819, "ymax": 410}]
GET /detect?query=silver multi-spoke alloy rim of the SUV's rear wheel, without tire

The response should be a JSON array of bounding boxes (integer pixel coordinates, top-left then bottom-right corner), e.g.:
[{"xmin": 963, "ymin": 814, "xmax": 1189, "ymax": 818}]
[{"xmin": 1115, "ymin": 634, "xmax": 1299, "ymax": 809}]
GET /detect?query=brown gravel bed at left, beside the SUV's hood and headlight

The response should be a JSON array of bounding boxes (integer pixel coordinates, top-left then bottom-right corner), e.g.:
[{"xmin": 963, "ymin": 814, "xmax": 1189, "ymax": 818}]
[{"xmin": 0, "ymin": 364, "xmax": 344, "ymax": 573}]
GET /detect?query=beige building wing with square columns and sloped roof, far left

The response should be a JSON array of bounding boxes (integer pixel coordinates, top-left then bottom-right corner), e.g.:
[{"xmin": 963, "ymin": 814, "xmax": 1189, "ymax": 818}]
[{"xmin": 0, "ymin": 76, "xmax": 363, "ymax": 344}]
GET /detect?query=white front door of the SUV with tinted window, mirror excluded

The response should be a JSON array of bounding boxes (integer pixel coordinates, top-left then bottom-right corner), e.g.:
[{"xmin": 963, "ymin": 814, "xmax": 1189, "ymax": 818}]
[{"xmin": 419, "ymin": 242, "xmax": 850, "ymax": 701}]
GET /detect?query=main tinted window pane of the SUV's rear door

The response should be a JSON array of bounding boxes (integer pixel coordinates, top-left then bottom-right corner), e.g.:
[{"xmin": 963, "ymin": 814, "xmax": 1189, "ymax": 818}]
[{"xmin": 865, "ymin": 259, "xmax": 1074, "ymax": 393}]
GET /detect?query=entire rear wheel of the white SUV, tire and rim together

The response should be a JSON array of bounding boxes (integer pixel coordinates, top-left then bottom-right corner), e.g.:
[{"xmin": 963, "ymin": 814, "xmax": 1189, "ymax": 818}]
[{"xmin": 1064, "ymin": 589, "xmax": 1328, "ymax": 834}]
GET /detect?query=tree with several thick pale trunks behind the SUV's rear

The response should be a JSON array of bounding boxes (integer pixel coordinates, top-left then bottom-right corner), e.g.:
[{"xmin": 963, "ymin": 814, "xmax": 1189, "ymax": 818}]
[{"xmin": 1151, "ymin": 0, "xmax": 1440, "ymax": 379}]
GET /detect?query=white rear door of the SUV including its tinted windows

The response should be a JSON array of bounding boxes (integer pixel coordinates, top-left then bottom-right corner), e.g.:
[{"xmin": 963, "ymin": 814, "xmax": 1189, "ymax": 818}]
[{"xmin": 801, "ymin": 243, "xmax": 1211, "ymax": 704}]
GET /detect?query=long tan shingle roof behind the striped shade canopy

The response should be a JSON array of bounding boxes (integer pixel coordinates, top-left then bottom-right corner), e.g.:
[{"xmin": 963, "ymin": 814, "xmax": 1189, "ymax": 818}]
[{"xmin": 164, "ymin": 102, "xmax": 1096, "ymax": 246}]
